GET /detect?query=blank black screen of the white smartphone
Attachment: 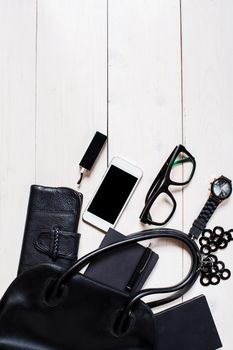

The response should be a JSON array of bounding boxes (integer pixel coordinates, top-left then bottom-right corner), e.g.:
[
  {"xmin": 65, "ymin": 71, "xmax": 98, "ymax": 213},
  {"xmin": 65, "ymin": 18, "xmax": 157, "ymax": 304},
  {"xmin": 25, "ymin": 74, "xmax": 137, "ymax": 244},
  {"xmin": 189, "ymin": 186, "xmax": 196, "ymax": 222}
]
[{"xmin": 87, "ymin": 165, "xmax": 138, "ymax": 224}]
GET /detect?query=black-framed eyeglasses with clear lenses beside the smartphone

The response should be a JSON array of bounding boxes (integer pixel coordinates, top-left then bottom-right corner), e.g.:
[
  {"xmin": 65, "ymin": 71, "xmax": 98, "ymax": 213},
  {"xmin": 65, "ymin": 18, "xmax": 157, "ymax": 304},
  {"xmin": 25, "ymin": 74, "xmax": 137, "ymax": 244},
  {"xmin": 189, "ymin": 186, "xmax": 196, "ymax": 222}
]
[{"xmin": 140, "ymin": 145, "xmax": 196, "ymax": 226}]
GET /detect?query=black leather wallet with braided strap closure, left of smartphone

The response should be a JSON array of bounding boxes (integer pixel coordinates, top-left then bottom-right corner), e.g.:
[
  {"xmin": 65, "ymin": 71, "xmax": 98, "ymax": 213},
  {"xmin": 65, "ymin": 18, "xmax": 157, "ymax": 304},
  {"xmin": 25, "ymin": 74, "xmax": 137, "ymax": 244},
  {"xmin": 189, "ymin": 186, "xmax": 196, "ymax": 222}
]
[{"xmin": 18, "ymin": 185, "xmax": 83, "ymax": 274}]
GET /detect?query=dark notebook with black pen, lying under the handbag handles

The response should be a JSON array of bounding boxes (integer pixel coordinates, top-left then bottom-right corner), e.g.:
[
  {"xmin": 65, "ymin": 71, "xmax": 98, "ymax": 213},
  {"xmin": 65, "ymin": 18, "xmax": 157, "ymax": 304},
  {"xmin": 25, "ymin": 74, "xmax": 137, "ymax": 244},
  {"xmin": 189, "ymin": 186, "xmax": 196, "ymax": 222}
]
[{"xmin": 85, "ymin": 228, "xmax": 159, "ymax": 293}]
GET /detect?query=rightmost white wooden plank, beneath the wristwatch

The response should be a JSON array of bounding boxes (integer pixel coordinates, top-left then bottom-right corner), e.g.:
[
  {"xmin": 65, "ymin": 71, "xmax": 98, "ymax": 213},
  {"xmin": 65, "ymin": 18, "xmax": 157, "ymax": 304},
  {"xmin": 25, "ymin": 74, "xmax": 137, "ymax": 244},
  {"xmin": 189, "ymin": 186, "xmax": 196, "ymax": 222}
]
[{"xmin": 182, "ymin": 0, "xmax": 233, "ymax": 350}]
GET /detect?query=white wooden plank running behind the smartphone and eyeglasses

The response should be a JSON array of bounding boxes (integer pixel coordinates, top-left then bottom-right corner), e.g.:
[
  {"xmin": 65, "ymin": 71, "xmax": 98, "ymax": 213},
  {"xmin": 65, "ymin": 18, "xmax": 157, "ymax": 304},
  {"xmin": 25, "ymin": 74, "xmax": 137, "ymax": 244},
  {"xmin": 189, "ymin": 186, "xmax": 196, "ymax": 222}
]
[{"xmin": 109, "ymin": 0, "xmax": 182, "ymax": 306}]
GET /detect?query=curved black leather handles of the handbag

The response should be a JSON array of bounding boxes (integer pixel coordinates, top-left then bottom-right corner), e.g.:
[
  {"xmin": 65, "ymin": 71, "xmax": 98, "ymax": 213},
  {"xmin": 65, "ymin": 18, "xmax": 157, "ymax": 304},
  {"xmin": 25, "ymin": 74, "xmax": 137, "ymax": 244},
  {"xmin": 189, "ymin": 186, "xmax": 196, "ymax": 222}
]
[{"xmin": 52, "ymin": 228, "xmax": 201, "ymax": 317}]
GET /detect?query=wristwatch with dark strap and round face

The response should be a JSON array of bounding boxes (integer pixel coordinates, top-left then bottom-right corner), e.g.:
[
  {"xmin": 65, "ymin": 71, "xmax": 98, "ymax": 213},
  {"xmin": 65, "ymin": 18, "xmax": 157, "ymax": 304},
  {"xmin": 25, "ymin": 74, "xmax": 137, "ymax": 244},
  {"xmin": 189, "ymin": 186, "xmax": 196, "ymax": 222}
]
[{"xmin": 189, "ymin": 175, "xmax": 232, "ymax": 238}]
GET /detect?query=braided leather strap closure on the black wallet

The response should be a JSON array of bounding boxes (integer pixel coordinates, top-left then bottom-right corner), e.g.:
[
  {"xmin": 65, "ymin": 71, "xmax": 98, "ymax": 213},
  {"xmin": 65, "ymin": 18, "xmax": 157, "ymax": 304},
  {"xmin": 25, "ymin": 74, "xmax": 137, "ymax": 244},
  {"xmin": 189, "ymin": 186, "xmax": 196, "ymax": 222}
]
[{"xmin": 34, "ymin": 228, "xmax": 80, "ymax": 261}]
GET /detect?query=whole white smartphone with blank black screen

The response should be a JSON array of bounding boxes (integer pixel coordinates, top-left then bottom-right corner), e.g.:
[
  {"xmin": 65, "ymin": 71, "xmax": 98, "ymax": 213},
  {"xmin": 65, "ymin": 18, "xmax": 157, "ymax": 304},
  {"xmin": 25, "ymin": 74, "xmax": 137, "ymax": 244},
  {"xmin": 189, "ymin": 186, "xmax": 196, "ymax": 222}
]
[{"xmin": 83, "ymin": 157, "xmax": 142, "ymax": 231}]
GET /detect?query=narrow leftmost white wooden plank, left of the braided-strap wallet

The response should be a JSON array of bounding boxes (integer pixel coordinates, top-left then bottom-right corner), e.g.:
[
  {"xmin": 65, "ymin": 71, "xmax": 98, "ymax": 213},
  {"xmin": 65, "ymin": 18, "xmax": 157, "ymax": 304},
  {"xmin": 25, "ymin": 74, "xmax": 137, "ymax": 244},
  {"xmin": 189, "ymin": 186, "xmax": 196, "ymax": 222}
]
[{"xmin": 0, "ymin": 0, "xmax": 36, "ymax": 294}]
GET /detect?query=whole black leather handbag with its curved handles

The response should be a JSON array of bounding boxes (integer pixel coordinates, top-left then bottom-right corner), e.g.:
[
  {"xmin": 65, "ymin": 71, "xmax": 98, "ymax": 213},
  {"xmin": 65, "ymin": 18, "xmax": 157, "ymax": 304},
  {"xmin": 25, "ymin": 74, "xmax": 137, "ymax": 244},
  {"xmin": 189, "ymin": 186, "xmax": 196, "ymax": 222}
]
[{"xmin": 0, "ymin": 229, "xmax": 221, "ymax": 350}]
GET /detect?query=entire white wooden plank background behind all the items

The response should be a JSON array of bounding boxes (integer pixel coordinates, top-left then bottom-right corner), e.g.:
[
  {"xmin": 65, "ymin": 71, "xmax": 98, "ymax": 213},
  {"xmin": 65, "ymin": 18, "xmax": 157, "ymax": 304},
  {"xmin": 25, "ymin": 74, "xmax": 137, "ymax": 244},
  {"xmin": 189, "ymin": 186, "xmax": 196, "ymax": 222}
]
[{"xmin": 0, "ymin": 0, "xmax": 233, "ymax": 350}]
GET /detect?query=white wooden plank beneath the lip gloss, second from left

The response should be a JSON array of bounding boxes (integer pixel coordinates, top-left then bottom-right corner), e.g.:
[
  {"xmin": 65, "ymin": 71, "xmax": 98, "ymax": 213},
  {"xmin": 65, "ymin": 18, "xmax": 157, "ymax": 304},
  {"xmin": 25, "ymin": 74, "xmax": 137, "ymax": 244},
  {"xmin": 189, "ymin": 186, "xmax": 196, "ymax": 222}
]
[{"xmin": 36, "ymin": 0, "xmax": 107, "ymax": 255}]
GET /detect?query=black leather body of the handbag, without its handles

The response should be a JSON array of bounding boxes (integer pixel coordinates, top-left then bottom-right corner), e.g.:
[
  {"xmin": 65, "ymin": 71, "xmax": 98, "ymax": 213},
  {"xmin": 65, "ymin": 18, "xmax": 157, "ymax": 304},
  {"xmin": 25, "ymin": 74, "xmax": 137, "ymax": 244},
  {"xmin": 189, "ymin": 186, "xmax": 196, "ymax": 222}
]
[{"xmin": 0, "ymin": 264, "xmax": 155, "ymax": 350}]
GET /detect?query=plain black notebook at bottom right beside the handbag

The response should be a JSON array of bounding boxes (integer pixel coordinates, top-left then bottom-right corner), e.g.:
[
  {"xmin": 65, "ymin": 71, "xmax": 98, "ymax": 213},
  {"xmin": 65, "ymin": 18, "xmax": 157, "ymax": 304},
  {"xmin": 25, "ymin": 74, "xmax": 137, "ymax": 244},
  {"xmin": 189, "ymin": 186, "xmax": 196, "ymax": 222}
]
[{"xmin": 154, "ymin": 295, "xmax": 222, "ymax": 350}]
